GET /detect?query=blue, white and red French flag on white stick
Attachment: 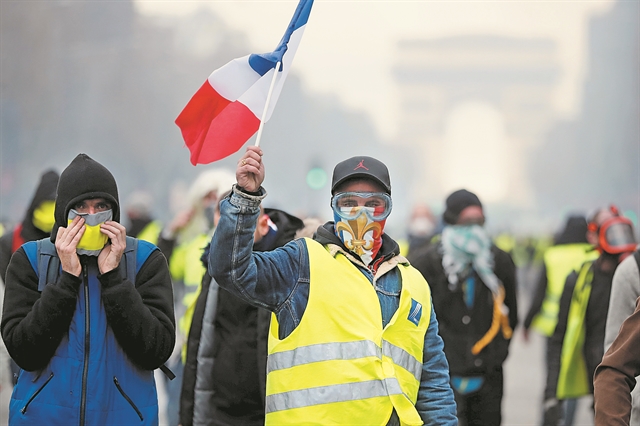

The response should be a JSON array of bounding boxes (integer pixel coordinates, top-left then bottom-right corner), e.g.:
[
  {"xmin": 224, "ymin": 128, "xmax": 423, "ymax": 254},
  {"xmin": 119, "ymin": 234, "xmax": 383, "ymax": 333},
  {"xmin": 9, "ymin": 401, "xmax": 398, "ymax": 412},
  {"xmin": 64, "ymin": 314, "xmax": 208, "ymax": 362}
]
[{"xmin": 176, "ymin": 0, "xmax": 313, "ymax": 165}]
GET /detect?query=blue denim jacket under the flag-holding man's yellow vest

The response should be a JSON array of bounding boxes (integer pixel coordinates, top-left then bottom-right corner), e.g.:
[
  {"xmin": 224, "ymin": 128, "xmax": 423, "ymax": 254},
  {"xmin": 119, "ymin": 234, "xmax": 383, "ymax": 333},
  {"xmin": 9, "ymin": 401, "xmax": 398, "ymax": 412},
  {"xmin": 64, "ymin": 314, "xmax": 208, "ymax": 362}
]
[{"xmin": 209, "ymin": 187, "xmax": 457, "ymax": 425}]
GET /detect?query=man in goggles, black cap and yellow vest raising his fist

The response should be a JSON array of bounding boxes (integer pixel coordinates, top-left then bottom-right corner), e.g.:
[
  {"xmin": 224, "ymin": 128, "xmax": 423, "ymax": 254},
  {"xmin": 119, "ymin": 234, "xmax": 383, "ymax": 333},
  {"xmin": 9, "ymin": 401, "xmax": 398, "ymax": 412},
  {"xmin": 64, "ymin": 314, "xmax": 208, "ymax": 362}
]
[{"xmin": 209, "ymin": 146, "xmax": 457, "ymax": 425}]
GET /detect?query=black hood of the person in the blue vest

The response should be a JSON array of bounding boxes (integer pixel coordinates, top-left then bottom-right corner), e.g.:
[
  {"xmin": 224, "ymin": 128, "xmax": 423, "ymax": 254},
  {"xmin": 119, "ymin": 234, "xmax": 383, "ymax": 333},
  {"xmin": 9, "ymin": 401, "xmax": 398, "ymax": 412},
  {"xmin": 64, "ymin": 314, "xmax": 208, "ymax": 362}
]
[{"xmin": 51, "ymin": 154, "xmax": 120, "ymax": 242}]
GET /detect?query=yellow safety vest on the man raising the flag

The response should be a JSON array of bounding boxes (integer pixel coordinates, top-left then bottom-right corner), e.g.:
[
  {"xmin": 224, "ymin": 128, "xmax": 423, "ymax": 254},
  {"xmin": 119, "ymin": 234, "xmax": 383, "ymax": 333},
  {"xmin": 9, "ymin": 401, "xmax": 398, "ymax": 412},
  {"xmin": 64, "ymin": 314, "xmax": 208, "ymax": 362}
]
[{"xmin": 265, "ymin": 238, "xmax": 431, "ymax": 425}]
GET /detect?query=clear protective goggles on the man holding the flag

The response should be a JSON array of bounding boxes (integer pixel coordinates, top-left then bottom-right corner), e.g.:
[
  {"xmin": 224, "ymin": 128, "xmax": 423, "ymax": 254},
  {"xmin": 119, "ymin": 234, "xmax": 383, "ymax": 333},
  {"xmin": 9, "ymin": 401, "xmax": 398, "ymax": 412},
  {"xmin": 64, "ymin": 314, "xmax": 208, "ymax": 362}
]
[{"xmin": 331, "ymin": 192, "xmax": 393, "ymax": 222}]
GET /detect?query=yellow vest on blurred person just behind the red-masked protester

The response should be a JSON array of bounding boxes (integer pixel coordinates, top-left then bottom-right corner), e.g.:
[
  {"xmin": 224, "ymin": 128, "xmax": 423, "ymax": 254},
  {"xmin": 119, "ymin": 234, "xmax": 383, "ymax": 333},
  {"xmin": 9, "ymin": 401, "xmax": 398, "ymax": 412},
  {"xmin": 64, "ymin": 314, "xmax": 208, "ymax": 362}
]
[{"xmin": 531, "ymin": 243, "xmax": 598, "ymax": 337}]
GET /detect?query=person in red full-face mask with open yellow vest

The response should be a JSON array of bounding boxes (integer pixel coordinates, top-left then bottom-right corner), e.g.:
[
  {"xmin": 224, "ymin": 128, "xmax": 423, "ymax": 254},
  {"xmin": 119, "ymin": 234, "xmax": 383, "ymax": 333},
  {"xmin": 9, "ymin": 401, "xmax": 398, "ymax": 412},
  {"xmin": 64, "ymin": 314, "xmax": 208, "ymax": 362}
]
[{"xmin": 544, "ymin": 206, "xmax": 637, "ymax": 426}]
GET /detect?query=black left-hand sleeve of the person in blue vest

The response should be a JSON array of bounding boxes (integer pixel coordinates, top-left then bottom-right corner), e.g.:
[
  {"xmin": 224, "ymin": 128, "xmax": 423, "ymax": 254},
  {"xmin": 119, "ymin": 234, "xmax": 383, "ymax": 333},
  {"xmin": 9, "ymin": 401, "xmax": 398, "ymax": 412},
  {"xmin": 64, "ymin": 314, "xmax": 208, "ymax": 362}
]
[{"xmin": 1, "ymin": 248, "xmax": 81, "ymax": 371}]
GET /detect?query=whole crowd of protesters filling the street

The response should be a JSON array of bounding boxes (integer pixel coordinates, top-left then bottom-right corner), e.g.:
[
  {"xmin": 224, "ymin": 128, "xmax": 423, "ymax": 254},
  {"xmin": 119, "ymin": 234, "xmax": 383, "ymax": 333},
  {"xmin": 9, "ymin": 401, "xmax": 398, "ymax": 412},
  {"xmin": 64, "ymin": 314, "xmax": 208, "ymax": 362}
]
[{"xmin": 0, "ymin": 154, "xmax": 640, "ymax": 426}]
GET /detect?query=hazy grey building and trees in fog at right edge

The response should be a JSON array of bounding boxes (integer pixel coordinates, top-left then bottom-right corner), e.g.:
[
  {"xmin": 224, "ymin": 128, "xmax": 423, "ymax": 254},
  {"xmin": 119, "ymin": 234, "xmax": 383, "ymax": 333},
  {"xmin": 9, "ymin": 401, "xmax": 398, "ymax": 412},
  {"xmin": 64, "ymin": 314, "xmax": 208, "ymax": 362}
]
[{"xmin": 532, "ymin": 1, "xmax": 640, "ymax": 223}]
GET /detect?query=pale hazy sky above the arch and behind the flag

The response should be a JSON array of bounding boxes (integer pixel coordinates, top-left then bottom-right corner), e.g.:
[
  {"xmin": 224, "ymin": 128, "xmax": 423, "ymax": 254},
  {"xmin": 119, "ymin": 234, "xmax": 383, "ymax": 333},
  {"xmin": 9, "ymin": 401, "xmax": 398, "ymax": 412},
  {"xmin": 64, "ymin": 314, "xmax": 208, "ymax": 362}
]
[{"xmin": 137, "ymin": 0, "xmax": 613, "ymax": 137}]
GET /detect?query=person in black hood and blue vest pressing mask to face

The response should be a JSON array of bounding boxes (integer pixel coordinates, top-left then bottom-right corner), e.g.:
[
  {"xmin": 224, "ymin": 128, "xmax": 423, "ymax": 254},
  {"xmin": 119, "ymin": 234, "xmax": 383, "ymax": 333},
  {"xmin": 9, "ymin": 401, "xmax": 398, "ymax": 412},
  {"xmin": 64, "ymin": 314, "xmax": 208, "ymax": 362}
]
[{"xmin": 1, "ymin": 154, "xmax": 175, "ymax": 425}]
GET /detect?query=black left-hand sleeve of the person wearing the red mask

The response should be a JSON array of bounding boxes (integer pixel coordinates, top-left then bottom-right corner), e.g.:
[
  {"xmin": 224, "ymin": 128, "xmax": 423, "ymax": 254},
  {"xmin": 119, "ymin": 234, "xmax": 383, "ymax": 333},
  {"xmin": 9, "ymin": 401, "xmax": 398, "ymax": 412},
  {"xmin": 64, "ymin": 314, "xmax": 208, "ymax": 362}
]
[{"xmin": 544, "ymin": 272, "xmax": 578, "ymax": 399}]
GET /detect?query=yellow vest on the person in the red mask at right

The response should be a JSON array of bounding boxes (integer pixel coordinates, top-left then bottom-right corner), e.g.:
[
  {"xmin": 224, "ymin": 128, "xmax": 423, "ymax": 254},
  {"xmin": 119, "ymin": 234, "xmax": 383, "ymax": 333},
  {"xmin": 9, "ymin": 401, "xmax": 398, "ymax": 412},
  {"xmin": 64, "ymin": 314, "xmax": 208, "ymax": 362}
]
[{"xmin": 556, "ymin": 260, "xmax": 593, "ymax": 399}]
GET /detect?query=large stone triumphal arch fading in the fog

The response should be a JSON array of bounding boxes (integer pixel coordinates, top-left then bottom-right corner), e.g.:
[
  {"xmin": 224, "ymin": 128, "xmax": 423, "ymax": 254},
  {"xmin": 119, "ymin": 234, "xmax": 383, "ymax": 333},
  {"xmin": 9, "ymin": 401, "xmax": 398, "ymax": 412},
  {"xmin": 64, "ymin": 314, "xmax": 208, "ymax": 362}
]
[{"xmin": 394, "ymin": 35, "xmax": 559, "ymax": 210}]
